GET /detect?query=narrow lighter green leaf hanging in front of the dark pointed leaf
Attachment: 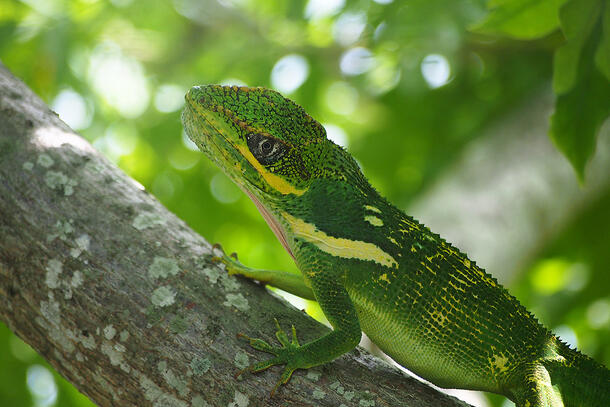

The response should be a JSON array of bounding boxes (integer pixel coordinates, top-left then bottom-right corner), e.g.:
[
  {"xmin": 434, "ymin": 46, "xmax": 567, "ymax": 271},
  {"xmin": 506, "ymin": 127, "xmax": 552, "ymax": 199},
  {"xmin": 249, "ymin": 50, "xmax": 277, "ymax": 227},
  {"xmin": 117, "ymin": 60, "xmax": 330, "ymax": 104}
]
[{"xmin": 553, "ymin": 0, "xmax": 602, "ymax": 95}]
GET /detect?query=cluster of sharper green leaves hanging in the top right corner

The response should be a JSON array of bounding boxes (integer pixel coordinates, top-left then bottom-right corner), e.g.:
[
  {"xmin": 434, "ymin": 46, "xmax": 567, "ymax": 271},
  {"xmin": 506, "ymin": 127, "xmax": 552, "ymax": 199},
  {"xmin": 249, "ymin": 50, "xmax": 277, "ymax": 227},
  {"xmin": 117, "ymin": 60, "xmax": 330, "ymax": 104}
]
[{"xmin": 474, "ymin": 0, "xmax": 610, "ymax": 181}]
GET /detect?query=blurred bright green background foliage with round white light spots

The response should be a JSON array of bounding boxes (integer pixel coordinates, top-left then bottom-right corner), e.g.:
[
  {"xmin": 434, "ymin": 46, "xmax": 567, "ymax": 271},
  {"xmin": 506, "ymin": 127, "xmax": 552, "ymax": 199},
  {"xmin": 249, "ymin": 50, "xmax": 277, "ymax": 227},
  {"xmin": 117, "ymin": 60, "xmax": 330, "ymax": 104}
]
[{"xmin": 0, "ymin": 0, "xmax": 610, "ymax": 406}]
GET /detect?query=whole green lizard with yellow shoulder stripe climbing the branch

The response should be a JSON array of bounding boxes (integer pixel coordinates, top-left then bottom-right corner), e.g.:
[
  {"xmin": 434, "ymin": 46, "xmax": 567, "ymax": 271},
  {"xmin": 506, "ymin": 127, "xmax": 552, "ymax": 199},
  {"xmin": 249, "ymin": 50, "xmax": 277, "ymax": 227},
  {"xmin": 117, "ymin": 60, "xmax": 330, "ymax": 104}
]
[{"xmin": 182, "ymin": 86, "xmax": 610, "ymax": 407}]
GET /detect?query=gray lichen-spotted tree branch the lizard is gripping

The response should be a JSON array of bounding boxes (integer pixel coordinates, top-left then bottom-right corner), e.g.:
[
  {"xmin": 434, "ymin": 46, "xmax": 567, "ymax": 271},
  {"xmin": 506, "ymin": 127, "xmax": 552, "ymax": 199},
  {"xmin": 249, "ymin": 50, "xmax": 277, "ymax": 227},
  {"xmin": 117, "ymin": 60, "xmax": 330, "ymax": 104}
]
[{"xmin": 0, "ymin": 64, "xmax": 464, "ymax": 407}]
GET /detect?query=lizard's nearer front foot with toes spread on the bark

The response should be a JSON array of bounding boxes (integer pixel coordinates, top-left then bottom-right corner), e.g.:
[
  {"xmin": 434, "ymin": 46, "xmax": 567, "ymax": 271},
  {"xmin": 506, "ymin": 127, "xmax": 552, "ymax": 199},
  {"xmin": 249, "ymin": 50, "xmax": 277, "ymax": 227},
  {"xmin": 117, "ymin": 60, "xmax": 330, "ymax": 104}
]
[{"xmin": 236, "ymin": 318, "xmax": 307, "ymax": 397}]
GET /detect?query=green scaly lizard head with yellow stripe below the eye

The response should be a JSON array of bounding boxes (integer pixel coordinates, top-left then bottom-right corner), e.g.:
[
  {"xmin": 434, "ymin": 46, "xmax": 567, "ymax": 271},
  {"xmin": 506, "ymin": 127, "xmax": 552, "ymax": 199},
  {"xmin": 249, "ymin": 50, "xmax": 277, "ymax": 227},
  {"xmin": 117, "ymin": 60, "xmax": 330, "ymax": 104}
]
[{"xmin": 182, "ymin": 85, "xmax": 357, "ymax": 202}]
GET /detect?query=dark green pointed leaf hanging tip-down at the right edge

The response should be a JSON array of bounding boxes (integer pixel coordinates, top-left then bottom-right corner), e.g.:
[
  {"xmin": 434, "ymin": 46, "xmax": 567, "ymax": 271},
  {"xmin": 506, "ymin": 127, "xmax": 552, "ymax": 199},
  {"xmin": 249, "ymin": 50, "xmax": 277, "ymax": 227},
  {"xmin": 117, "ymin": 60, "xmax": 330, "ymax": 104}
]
[{"xmin": 550, "ymin": 18, "xmax": 610, "ymax": 182}]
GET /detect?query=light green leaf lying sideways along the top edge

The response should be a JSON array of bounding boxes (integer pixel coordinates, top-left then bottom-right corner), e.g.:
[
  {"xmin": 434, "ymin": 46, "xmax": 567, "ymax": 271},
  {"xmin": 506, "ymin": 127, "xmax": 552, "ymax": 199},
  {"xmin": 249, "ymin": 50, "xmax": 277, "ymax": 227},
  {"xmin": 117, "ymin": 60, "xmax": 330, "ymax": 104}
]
[{"xmin": 472, "ymin": 0, "xmax": 566, "ymax": 40}]
